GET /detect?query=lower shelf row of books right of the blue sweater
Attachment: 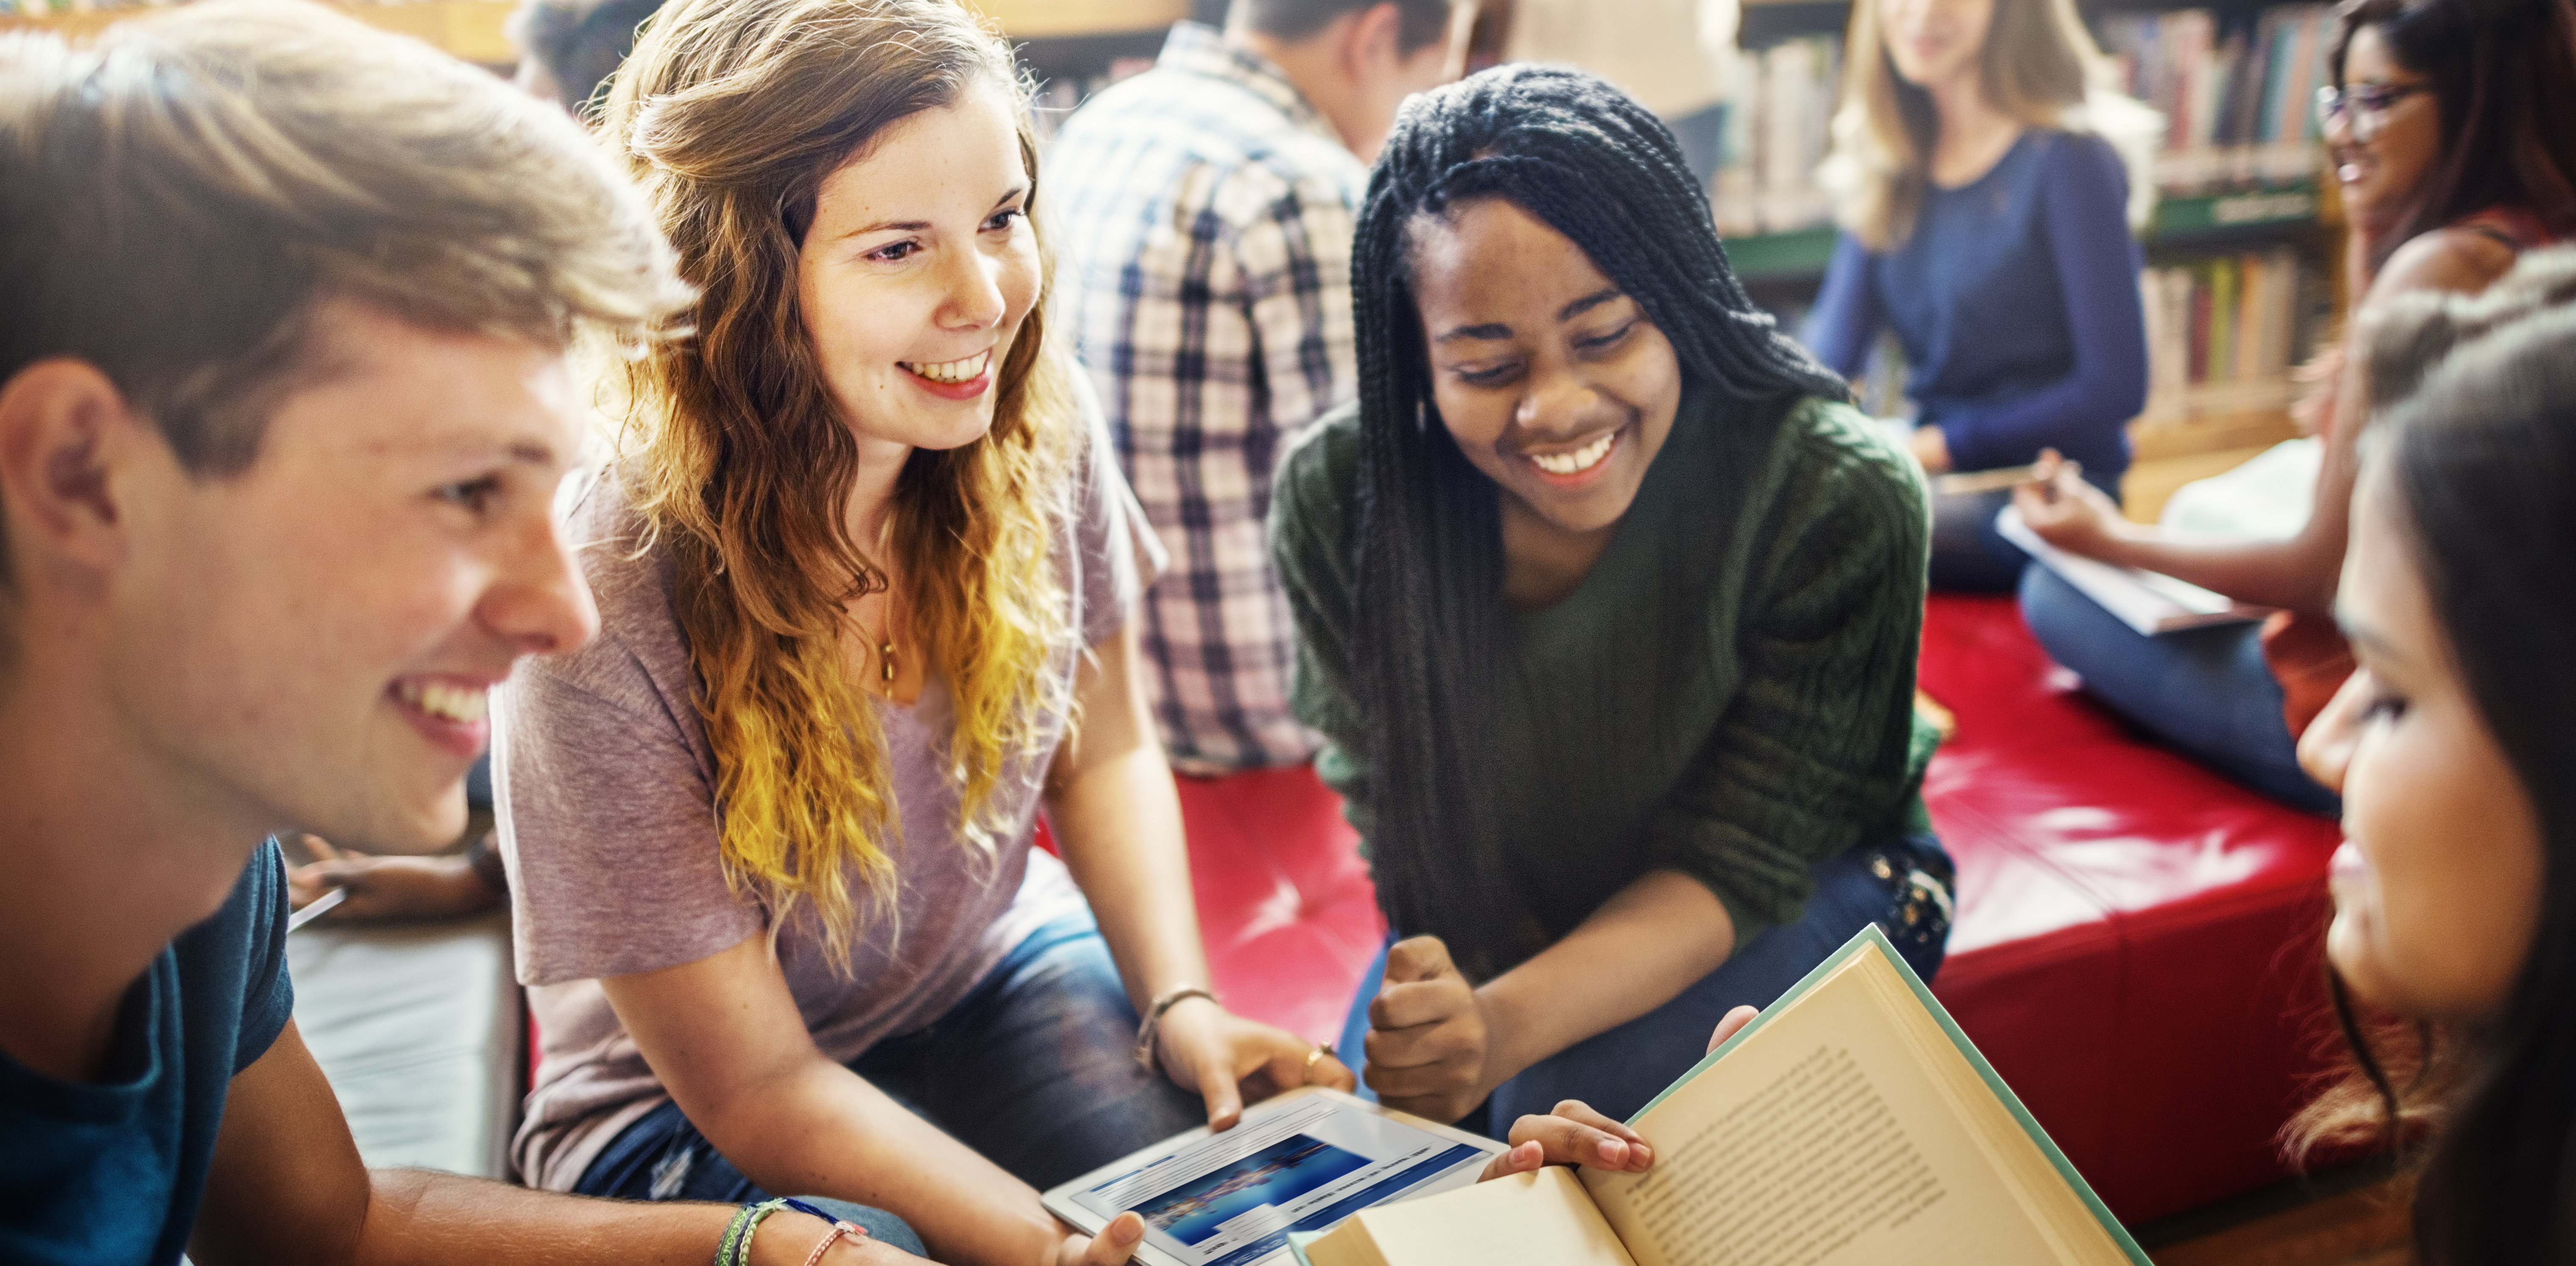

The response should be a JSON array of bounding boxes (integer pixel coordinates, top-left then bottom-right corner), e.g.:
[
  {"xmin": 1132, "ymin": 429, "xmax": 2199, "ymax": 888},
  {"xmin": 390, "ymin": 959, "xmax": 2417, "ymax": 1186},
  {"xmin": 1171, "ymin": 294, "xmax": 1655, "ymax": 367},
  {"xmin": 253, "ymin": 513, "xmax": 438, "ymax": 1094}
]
[{"xmin": 2138, "ymin": 247, "xmax": 2331, "ymax": 412}]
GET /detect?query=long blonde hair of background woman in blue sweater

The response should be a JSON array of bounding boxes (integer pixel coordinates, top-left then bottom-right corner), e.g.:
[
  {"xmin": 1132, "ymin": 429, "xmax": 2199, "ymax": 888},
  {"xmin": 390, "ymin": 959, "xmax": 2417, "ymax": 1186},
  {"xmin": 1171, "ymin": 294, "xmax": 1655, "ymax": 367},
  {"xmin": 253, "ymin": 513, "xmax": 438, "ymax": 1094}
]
[{"xmin": 1816, "ymin": 0, "xmax": 2164, "ymax": 249}]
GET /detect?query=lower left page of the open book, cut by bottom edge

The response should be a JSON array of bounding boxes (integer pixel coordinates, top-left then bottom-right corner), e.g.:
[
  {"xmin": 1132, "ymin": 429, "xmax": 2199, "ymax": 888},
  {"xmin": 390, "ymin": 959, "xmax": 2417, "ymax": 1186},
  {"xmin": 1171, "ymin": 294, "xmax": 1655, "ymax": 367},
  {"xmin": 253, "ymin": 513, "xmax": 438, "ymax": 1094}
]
[{"xmin": 1306, "ymin": 1166, "xmax": 1636, "ymax": 1266}]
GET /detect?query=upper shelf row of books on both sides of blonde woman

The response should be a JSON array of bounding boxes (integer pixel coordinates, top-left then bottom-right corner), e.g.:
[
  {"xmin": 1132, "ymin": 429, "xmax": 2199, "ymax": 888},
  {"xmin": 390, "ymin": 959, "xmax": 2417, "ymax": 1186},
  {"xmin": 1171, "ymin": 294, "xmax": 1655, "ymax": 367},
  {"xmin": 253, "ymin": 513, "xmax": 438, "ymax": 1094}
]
[{"xmin": 1710, "ymin": 5, "xmax": 2334, "ymax": 237}]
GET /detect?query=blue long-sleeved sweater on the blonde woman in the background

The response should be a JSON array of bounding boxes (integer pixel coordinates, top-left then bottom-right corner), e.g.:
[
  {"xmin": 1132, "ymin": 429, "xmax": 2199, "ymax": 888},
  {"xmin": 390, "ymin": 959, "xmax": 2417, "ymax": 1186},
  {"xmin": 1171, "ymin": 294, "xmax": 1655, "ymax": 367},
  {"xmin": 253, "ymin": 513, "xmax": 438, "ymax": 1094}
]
[{"xmin": 1806, "ymin": 131, "xmax": 2146, "ymax": 486}]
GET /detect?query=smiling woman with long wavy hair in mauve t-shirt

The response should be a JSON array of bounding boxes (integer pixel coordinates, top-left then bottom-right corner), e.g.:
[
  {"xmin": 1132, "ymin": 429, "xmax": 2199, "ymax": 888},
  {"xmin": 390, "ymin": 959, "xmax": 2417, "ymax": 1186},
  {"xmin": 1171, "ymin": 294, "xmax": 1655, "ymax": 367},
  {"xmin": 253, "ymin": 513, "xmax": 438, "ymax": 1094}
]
[{"xmin": 497, "ymin": 0, "xmax": 1350, "ymax": 1263}]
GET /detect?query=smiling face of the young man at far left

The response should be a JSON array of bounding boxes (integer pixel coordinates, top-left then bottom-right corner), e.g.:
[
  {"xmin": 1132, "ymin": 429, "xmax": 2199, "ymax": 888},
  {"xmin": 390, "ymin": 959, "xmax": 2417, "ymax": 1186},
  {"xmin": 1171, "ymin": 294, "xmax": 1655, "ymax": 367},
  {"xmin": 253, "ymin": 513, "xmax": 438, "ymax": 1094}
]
[{"xmin": 122, "ymin": 301, "xmax": 598, "ymax": 852}]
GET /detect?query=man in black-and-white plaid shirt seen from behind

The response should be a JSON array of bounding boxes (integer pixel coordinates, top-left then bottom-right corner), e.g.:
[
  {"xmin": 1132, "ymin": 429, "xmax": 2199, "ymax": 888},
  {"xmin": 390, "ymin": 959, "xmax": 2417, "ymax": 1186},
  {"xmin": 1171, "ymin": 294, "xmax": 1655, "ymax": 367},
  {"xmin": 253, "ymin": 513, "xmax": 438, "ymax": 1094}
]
[{"xmin": 1046, "ymin": 0, "xmax": 1450, "ymax": 774}]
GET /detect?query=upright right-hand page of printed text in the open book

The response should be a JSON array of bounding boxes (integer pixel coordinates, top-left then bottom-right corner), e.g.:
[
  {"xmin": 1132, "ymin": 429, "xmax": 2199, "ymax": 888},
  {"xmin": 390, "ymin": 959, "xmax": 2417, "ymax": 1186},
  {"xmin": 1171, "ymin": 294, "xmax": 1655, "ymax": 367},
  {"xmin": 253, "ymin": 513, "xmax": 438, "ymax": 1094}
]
[{"xmin": 1582, "ymin": 955, "xmax": 2063, "ymax": 1266}]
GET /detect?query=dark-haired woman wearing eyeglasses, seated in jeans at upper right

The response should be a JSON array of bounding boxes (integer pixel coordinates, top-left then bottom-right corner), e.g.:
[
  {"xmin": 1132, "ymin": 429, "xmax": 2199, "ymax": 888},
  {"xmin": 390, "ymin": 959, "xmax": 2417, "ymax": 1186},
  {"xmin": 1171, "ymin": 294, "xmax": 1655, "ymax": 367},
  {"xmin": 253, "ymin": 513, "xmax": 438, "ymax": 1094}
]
[{"xmin": 2014, "ymin": 0, "xmax": 2576, "ymax": 813}]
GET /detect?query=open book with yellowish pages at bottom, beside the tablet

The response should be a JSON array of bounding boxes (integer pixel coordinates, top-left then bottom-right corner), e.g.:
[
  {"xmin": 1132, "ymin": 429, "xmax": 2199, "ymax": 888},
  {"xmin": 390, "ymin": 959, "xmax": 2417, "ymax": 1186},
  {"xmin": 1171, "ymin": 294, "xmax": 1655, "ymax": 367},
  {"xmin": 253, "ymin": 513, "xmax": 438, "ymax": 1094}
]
[{"xmin": 1291, "ymin": 926, "xmax": 2148, "ymax": 1266}]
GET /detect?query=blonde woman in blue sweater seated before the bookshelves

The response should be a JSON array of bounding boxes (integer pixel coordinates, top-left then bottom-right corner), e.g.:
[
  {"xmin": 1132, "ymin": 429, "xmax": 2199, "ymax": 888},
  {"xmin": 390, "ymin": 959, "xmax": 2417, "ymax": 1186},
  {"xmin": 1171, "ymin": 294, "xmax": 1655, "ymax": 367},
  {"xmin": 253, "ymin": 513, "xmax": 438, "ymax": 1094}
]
[{"xmin": 1806, "ymin": 0, "xmax": 2153, "ymax": 592}]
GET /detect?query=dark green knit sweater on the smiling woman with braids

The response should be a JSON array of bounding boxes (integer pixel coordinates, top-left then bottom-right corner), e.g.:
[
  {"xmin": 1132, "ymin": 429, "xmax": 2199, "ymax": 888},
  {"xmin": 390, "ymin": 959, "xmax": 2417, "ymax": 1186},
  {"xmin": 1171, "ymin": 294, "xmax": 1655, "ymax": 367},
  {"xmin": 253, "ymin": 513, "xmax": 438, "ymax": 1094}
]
[{"xmin": 1270, "ymin": 394, "xmax": 1937, "ymax": 944}]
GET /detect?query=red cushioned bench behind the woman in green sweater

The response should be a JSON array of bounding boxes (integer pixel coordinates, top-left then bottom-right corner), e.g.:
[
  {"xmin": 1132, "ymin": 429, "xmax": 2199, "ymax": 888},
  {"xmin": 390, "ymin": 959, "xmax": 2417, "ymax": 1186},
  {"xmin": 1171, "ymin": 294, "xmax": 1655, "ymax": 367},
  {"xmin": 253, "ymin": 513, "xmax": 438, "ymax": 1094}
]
[{"xmin": 1180, "ymin": 597, "xmax": 2336, "ymax": 1222}]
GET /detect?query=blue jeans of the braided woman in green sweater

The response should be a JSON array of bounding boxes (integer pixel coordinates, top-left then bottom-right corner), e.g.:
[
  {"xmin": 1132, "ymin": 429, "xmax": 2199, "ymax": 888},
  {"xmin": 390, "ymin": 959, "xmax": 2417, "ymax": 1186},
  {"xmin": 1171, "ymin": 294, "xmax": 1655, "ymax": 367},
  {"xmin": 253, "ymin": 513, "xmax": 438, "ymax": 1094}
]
[{"xmin": 1337, "ymin": 836, "xmax": 1953, "ymax": 1137}]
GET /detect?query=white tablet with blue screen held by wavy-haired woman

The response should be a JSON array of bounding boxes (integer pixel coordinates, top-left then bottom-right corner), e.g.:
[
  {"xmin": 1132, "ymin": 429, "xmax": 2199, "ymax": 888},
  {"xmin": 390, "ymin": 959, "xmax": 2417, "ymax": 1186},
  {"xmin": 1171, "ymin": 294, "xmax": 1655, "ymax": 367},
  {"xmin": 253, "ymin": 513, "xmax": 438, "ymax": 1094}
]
[{"xmin": 1046, "ymin": 1086, "xmax": 1502, "ymax": 1266}]
